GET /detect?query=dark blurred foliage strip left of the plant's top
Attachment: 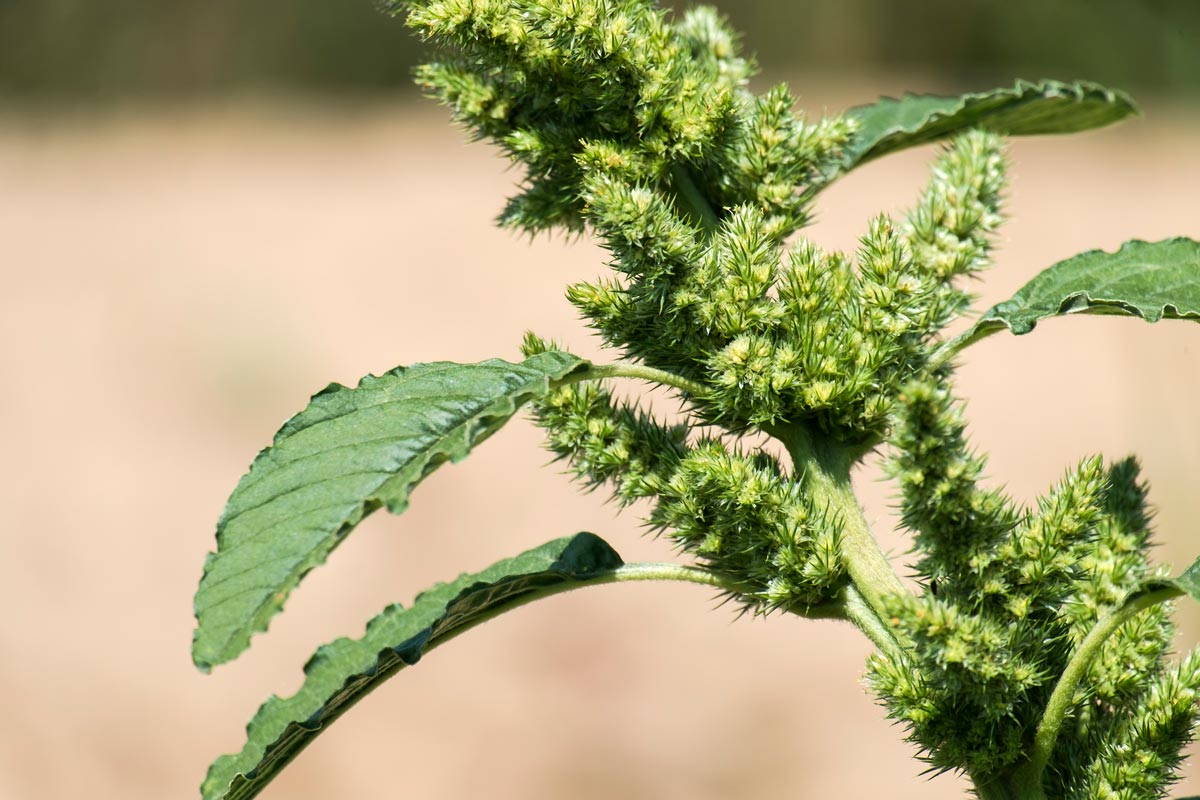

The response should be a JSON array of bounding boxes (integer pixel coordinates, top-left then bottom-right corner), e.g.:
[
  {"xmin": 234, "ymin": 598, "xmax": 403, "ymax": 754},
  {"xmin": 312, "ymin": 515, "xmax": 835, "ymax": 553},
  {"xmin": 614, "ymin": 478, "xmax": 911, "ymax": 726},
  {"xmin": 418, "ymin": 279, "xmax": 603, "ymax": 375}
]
[{"xmin": 0, "ymin": 0, "xmax": 419, "ymax": 100}]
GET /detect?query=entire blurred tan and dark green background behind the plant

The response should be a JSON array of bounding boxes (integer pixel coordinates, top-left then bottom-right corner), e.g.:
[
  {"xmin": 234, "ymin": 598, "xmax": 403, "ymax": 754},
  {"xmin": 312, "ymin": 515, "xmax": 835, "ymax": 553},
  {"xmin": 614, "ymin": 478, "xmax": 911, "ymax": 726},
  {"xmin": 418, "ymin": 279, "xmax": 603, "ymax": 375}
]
[{"xmin": 0, "ymin": 0, "xmax": 1200, "ymax": 800}]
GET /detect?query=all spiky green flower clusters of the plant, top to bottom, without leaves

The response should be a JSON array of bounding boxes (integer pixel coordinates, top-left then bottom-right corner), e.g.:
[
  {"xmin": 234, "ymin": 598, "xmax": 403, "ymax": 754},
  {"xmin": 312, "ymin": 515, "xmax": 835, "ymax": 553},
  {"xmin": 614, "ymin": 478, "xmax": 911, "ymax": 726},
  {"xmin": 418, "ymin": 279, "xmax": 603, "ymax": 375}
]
[{"xmin": 396, "ymin": 0, "xmax": 1200, "ymax": 800}]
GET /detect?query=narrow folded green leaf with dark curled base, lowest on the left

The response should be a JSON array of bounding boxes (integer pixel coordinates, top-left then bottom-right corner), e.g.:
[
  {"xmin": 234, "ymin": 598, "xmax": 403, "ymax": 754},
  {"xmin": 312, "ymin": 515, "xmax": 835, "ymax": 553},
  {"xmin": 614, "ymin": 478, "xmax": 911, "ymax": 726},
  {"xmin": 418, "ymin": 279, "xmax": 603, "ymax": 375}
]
[{"xmin": 200, "ymin": 533, "xmax": 623, "ymax": 800}]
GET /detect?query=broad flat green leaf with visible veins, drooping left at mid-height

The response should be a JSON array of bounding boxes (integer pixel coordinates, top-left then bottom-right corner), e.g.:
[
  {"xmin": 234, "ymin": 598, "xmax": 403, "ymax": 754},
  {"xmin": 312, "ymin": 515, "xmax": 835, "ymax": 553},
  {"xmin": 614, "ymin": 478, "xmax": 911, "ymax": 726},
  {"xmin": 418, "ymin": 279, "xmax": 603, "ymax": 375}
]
[{"xmin": 192, "ymin": 353, "xmax": 586, "ymax": 669}]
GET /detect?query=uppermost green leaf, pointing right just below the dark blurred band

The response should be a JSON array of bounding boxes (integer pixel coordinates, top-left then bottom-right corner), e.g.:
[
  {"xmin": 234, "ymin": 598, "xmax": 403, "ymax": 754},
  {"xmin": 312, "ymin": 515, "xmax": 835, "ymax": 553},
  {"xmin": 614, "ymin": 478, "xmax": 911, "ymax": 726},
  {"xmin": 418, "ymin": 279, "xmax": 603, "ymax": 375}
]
[{"xmin": 841, "ymin": 80, "xmax": 1138, "ymax": 172}]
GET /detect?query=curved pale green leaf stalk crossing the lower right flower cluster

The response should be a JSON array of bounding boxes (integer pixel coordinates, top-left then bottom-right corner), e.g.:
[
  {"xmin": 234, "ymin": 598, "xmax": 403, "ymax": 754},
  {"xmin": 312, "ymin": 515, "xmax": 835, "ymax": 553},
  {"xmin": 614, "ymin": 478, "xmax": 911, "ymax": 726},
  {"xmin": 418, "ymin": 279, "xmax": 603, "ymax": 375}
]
[{"xmin": 1015, "ymin": 587, "xmax": 1183, "ymax": 800}]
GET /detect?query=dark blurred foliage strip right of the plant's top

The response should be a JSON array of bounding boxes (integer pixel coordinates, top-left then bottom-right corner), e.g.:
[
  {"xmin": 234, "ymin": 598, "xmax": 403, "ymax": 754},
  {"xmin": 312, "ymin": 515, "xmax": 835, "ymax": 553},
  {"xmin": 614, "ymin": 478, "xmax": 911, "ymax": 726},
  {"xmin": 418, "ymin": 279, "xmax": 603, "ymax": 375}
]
[{"xmin": 722, "ymin": 0, "xmax": 1200, "ymax": 95}]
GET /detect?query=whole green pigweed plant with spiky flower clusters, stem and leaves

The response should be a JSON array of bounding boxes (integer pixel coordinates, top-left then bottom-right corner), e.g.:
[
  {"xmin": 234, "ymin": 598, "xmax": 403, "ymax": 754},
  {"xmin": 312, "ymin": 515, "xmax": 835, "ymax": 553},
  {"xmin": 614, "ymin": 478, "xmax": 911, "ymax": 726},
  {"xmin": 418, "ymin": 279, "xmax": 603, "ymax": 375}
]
[{"xmin": 193, "ymin": 0, "xmax": 1200, "ymax": 800}]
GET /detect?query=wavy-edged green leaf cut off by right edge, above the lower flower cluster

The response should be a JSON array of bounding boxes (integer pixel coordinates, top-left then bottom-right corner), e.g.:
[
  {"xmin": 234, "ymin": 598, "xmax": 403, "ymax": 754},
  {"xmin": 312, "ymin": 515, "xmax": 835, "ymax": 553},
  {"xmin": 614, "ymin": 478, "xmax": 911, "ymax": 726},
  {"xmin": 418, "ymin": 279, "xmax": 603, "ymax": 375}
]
[{"xmin": 974, "ymin": 237, "xmax": 1200, "ymax": 335}]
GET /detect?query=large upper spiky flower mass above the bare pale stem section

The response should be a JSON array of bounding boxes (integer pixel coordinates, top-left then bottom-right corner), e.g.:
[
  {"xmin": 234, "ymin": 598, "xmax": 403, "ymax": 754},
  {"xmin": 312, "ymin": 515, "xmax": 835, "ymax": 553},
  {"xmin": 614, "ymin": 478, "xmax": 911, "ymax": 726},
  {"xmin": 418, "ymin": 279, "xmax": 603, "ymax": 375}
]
[{"xmin": 408, "ymin": 0, "xmax": 1003, "ymax": 449}]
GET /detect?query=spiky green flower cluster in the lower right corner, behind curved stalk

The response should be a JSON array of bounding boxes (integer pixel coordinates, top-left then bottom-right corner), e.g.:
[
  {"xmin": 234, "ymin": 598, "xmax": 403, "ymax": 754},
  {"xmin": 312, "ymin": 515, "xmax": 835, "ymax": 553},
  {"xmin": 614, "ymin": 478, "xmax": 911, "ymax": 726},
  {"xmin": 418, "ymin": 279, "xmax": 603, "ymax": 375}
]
[{"xmin": 870, "ymin": 381, "xmax": 1200, "ymax": 800}]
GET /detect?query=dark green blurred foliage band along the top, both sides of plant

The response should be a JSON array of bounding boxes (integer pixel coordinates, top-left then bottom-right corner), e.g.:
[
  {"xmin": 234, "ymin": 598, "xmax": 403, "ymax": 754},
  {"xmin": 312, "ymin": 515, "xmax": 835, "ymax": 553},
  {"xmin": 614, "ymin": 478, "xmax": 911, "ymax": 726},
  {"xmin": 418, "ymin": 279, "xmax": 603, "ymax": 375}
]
[{"xmin": 0, "ymin": 0, "xmax": 1200, "ymax": 100}]
